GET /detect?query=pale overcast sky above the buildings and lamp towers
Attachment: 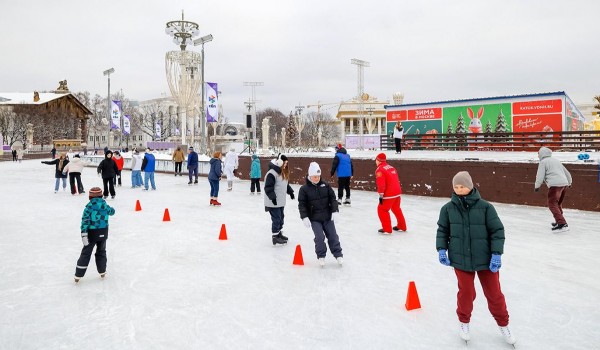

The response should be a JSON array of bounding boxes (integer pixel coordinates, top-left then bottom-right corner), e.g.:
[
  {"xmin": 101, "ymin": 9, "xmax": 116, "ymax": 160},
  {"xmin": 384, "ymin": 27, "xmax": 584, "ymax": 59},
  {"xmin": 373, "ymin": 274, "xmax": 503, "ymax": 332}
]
[{"xmin": 0, "ymin": 0, "xmax": 600, "ymax": 121}]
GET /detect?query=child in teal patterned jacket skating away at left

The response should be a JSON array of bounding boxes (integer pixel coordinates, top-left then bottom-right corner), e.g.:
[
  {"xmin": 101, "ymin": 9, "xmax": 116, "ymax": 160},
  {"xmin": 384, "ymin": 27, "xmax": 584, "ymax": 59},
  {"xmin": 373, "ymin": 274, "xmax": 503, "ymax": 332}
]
[{"xmin": 75, "ymin": 187, "xmax": 115, "ymax": 282}]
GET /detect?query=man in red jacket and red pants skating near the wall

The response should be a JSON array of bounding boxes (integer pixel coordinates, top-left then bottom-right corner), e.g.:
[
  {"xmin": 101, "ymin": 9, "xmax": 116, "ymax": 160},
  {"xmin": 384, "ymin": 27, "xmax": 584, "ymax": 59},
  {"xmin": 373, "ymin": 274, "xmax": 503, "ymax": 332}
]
[{"xmin": 375, "ymin": 153, "xmax": 406, "ymax": 235}]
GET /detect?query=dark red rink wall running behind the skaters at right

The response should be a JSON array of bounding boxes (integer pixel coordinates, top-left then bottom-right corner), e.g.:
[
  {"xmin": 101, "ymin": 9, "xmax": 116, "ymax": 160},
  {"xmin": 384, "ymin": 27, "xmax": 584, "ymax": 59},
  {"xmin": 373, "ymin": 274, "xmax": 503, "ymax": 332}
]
[{"xmin": 236, "ymin": 155, "xmax": 600, "ymax": 211}]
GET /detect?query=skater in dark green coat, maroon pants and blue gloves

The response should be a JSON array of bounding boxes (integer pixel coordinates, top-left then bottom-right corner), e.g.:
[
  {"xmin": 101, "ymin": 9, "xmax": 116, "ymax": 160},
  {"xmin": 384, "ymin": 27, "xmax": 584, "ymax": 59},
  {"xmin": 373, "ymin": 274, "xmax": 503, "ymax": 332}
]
[{"xmin": 436, "ymin": 171, "xmax": 516, "ymax": 344}]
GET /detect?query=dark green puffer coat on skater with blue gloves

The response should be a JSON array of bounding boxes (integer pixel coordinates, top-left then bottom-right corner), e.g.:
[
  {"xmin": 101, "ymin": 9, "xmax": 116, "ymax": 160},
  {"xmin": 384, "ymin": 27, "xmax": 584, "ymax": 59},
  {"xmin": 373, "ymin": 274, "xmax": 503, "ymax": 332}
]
[{"xmin": 436, "ymin": 188, "xmax": 504, "ymax": 271}]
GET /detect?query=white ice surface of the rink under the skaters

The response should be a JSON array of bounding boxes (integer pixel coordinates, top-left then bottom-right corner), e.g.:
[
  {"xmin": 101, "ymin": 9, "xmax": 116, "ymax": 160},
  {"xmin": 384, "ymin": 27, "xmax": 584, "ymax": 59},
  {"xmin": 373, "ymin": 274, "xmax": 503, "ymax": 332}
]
[{"xmin": 0, "ymin": 159, "xmax": 600, "ymax": 350}]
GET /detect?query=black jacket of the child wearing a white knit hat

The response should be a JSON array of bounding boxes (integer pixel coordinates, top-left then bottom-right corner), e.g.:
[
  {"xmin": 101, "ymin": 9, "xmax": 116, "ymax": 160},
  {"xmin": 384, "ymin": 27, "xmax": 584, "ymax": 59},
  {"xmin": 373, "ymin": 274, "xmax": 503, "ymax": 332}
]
[{"xmin": 298, "ymin": 178, "xmax": 338, "ymax": 222}]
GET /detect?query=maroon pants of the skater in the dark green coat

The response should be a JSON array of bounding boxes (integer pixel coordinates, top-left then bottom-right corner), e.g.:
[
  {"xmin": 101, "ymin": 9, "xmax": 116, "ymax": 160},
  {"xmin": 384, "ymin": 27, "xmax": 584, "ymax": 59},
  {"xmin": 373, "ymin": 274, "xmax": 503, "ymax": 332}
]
[{"xmin": 454, "ymin": 268, "xmax": 508, "ymax": 327}]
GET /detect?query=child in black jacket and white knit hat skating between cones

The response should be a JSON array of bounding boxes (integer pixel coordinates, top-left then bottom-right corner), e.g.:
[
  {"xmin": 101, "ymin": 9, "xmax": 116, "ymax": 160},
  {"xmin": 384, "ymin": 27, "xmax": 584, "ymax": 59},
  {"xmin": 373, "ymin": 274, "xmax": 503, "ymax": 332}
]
[{"xmin": 298, "ymin": 162, "xmax": 343, "ymax": 266}]
